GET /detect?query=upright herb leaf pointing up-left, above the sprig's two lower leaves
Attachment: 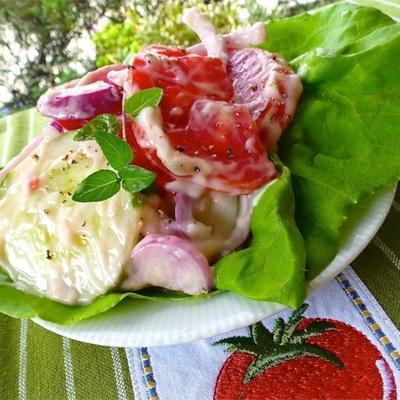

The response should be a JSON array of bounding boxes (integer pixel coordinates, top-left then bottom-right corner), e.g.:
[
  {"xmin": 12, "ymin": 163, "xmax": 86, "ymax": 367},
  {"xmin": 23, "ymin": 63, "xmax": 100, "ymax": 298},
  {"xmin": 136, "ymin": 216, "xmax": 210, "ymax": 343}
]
[{"xmin": 94, "ymin": 133, "xmax": 133, "ymax": 170}]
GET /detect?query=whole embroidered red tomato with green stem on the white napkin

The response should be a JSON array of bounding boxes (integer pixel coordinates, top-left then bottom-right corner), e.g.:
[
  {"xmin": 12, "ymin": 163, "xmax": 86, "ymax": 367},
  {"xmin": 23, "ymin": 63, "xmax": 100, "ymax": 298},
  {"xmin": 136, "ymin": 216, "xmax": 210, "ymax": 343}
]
[{"xmin": 214, "ymin": 305, "xmax": 396, "ymax": 400}]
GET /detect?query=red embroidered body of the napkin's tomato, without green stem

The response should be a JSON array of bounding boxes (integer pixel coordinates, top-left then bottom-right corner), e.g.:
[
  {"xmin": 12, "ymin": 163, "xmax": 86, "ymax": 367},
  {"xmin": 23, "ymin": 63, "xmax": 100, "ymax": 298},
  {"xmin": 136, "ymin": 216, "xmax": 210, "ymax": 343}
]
[{"xmin": 214, "ymin": 319, "xmax": 396, "ymax": 400}]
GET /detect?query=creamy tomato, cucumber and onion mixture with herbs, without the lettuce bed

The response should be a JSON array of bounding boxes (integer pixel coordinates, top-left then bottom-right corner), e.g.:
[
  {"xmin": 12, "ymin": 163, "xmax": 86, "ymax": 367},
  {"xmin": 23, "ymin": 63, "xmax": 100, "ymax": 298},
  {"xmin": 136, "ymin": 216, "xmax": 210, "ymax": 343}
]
[{"xmin": 0, "ymin": 9, "xmax": 302, "ymax": 304}]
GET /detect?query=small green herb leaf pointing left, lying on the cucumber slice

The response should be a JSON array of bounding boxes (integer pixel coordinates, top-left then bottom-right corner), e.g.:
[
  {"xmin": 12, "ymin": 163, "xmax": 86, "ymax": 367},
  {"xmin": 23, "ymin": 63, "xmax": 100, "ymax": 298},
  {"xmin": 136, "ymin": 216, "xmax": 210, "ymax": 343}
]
[{"xmin": 72, "ymin": 169, "xmax": 121, "ymax": 203}]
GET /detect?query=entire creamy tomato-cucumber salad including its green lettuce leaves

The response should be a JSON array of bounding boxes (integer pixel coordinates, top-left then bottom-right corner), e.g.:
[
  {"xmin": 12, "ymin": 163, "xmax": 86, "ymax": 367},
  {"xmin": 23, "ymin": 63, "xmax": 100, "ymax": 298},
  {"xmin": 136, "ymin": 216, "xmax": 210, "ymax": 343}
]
[{"xmin": 0, "ymin": 3, "xmax": 400, "ymax": 323}]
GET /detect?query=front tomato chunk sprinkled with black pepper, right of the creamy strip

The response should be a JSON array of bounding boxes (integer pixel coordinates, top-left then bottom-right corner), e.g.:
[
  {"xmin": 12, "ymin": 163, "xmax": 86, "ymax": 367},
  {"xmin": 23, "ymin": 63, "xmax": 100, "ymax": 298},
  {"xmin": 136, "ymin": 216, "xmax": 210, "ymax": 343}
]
[{"xmin": 166, "ymin": 99, "xmax": 275, "ymax": 194}]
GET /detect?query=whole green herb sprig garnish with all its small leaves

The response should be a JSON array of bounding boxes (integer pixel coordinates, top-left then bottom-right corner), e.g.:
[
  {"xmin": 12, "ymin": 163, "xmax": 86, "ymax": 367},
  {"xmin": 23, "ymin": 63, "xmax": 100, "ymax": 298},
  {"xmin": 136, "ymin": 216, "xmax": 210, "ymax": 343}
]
[{"xmin": 72, "ymin": 88, "xmax": 163, "ymax": 203}]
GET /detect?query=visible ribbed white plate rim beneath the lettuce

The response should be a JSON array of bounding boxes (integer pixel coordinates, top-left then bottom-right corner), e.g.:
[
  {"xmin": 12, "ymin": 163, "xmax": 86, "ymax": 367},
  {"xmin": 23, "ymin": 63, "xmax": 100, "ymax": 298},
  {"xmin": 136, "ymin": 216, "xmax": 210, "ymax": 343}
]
[{"xmin": 33, "ymin": 190, "xmax": 394, "ymax": 347}]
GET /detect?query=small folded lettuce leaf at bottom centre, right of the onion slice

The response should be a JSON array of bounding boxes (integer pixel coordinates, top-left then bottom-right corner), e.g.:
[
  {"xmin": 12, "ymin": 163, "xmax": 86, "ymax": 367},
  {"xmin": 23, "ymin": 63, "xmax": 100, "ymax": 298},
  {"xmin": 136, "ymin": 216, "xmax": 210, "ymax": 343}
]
[{"xmin": 215, "ymin": 164, "xmax": 306, "ymax": 307}]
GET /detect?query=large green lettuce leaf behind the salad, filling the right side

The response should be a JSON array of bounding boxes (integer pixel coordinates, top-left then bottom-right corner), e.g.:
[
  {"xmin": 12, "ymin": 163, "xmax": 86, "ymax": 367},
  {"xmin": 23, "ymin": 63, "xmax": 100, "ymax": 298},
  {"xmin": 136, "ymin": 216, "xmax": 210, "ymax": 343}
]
[{"xmin": 265, "ymin": 3, "xmax": 400, "ymax": 279}]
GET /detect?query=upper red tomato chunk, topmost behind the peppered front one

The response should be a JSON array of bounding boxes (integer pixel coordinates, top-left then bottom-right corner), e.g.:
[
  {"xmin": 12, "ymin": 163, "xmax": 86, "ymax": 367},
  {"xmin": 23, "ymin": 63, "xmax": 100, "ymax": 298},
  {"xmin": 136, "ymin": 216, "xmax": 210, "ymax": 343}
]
[{"xmin": 131, "ymin": 46, "xmax": 233, "ymax": 128}]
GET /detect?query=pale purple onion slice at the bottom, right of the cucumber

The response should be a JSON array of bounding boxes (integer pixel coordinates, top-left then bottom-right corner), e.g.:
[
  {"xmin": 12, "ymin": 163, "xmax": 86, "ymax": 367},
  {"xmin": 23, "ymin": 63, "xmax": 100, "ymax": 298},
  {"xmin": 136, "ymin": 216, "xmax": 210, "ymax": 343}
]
[{"xmin": 121, "ymin": 235, "xmax": 213, "ymax": 295}]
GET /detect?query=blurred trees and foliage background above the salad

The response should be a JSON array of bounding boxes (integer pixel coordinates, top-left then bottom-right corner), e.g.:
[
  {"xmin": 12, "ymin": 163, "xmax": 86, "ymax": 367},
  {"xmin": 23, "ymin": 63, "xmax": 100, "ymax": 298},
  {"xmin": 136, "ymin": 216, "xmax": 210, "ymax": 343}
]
[{"xmin": 0, "ymin": 0, "xmax": 335, "ymax": 115}]
